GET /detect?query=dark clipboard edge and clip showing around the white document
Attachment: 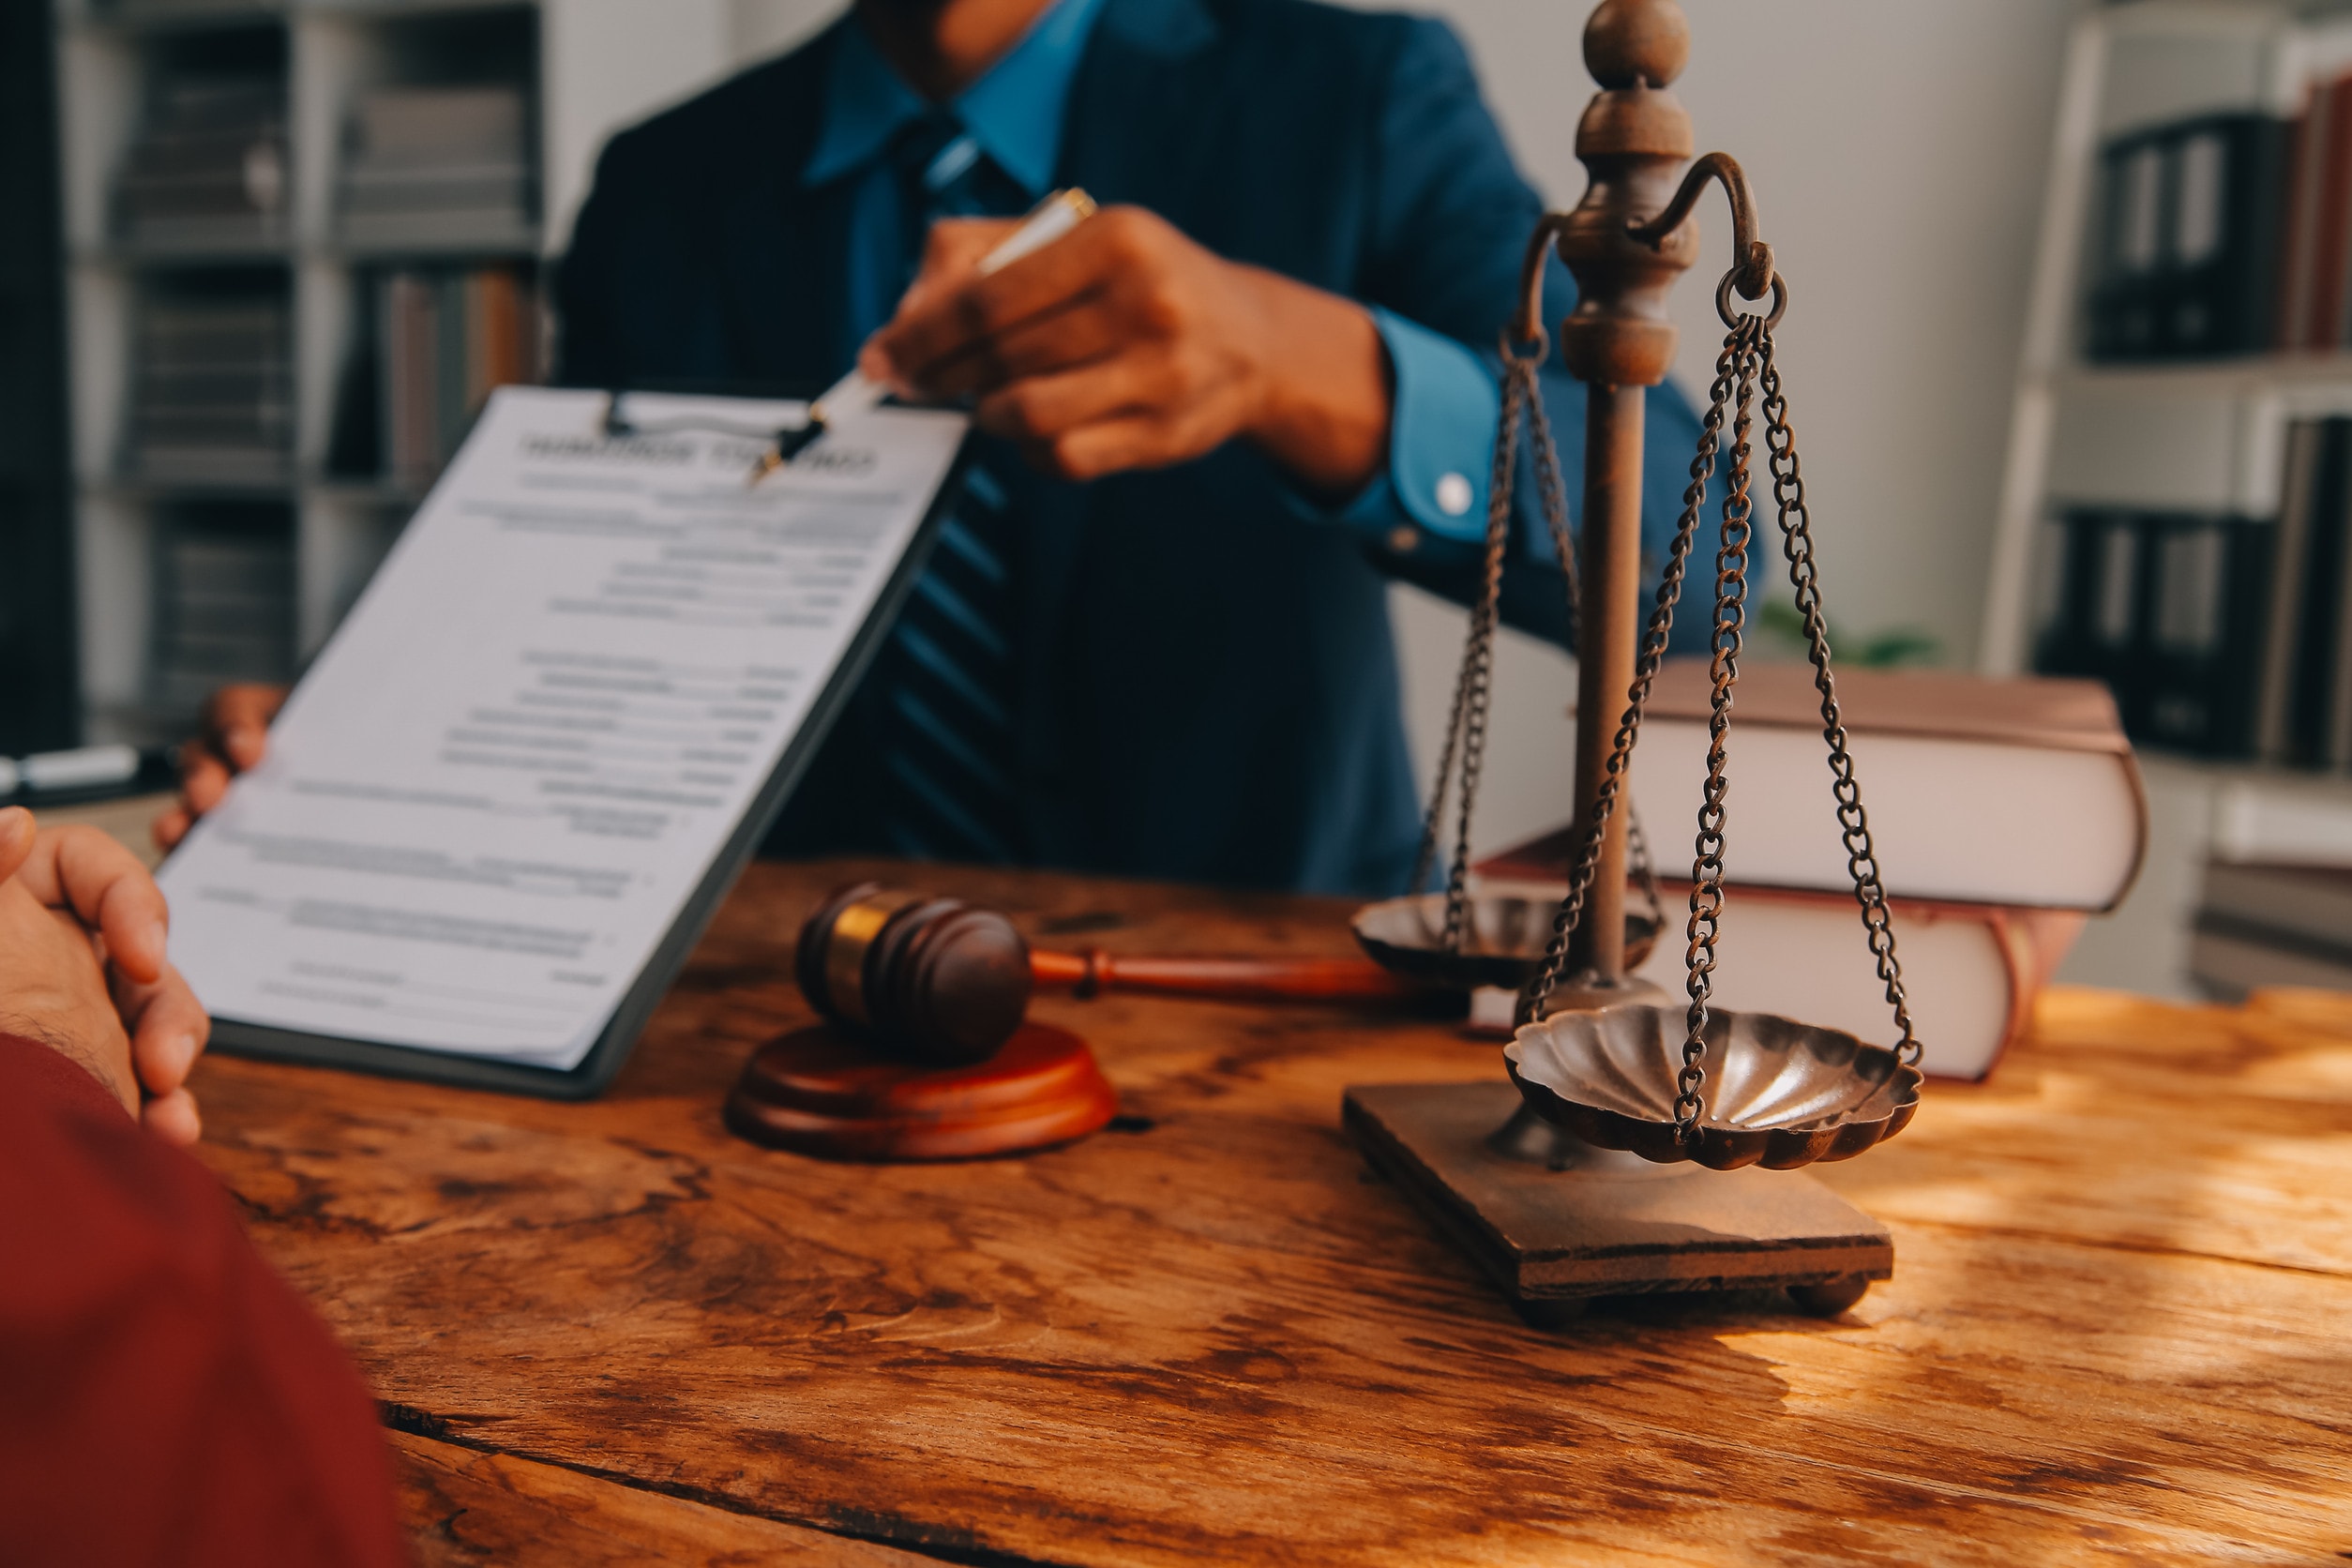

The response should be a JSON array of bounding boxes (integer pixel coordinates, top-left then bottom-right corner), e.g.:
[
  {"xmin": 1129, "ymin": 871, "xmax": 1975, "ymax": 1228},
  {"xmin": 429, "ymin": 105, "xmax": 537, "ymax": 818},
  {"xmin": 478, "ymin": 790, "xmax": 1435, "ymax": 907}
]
[{"xmin": 178, "ymin": 384, "xmax": 973, "ymax": 1100}]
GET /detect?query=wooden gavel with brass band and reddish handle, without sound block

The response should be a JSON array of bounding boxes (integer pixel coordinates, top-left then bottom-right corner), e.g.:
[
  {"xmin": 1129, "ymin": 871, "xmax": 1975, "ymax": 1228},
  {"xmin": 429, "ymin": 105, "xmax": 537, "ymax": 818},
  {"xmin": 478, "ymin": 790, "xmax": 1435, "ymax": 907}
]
[{"xmin": 792, "ymin": 882, "xmax": 1430, "ymax": 1063}]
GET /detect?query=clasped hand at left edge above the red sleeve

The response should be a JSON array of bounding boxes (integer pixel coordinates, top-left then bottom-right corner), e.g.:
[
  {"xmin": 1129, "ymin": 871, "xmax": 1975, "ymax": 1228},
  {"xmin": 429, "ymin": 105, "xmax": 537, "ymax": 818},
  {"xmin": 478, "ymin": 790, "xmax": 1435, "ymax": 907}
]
[{"xmin": 0, "ymin": 808, "xmax": 212, "ymax": 1142}]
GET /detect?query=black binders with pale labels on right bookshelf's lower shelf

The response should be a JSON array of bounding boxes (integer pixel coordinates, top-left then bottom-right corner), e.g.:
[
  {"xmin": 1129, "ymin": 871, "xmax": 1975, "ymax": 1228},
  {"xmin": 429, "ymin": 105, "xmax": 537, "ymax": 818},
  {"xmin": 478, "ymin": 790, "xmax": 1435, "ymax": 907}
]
[{"xmin": 2034, "ymin": 507, "xmax": 2282, "ymax": 757}]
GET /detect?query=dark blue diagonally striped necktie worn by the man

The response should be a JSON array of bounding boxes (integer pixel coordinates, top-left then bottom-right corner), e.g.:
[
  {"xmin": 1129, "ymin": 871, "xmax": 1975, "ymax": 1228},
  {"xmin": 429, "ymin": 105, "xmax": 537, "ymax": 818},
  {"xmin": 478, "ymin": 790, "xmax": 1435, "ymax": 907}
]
[{"xmin": 875, "ymin": 113, "xmax": 1028, "ymax": 863}]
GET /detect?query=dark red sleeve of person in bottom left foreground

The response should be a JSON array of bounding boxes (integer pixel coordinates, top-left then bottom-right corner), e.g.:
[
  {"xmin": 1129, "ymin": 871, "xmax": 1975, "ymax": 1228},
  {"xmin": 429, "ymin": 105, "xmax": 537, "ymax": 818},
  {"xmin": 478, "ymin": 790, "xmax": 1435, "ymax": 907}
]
[{"xmin": 0, "ymin": 1034, "xmax": 407, "ymax": 1568}]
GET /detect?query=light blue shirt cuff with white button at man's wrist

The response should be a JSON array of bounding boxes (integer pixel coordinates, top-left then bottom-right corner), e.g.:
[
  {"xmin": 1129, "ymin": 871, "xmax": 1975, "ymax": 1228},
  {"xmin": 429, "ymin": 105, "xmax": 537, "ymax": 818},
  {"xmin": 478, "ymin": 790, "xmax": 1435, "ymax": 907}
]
[{"xmin": 1298, "ymin": 306, "xmax": 1503, "ymax": 548}]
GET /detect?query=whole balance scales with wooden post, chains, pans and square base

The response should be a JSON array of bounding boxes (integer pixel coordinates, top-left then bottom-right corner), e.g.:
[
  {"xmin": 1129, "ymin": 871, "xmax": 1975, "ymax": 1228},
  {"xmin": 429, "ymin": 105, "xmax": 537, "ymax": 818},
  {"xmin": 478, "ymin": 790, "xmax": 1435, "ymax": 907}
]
[{"xmin": 1343, "ymin": 0, "xmax": 1922, "ymax": 1323}]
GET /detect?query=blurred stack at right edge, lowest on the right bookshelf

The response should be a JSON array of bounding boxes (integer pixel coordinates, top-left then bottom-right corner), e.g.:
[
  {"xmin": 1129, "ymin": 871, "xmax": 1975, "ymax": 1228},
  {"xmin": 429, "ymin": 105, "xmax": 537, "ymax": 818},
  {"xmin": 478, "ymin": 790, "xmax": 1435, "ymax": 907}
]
[{"xmin": 2190, "ymin": 860, "xmax": 2352, "ymax": 1002}]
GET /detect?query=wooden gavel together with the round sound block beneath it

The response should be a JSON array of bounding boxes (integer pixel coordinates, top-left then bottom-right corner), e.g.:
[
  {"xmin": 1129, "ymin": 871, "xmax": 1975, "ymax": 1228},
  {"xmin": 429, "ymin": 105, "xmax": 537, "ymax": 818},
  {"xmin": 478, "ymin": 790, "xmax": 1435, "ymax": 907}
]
[{"xmin": 727, "ymin": 882, "xmax": 1427, "ymax": 1161}]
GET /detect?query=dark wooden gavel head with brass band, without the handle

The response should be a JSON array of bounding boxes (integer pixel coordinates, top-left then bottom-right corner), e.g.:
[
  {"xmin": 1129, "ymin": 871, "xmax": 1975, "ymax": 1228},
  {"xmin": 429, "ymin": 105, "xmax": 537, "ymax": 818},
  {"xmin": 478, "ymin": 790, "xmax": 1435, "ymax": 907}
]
[{"xmin": 795, "ymin": 882, "xmax": 1031, "ymax": 1065}]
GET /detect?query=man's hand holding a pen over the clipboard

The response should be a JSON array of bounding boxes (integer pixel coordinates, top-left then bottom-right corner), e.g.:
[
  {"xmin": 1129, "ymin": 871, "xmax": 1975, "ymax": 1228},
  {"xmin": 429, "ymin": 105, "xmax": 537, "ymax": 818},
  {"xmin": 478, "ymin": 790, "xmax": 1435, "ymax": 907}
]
[{"xmin": 858, "ymin": 207, "xmax": 1390, "ymax": 496}]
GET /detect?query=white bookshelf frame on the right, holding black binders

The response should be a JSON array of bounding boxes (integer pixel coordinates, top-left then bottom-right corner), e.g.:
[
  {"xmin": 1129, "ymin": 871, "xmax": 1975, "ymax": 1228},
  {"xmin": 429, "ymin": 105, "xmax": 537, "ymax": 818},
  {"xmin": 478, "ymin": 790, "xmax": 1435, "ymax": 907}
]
[{"xmin": 1978, "ymin": 0, "xmax": 2352, "ymax": 997}]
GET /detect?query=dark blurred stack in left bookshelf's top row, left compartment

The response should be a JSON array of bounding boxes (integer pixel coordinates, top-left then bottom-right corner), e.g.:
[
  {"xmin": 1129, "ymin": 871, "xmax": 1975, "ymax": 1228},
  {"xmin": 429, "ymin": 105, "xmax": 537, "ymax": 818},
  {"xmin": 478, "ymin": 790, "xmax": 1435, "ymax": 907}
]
[{"xmin": 115, "ymin": 78, "xmax": 289, "ymax": 249}]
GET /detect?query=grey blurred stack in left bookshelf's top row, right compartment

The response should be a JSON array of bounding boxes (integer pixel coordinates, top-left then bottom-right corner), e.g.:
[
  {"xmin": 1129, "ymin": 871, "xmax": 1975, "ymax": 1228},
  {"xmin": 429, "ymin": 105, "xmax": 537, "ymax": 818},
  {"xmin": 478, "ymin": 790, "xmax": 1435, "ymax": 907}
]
[{"xmin": 341, "ymin": 87, "xmax": 538, "ymax": 249}]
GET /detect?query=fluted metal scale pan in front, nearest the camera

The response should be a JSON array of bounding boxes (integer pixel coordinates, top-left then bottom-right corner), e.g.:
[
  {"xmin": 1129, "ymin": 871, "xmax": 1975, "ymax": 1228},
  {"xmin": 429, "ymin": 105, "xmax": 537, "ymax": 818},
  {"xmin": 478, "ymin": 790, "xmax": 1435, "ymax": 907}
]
[{"xmin": 1503, "ymin": 1006, "xmax": 1920, "ymax": 1170}]
